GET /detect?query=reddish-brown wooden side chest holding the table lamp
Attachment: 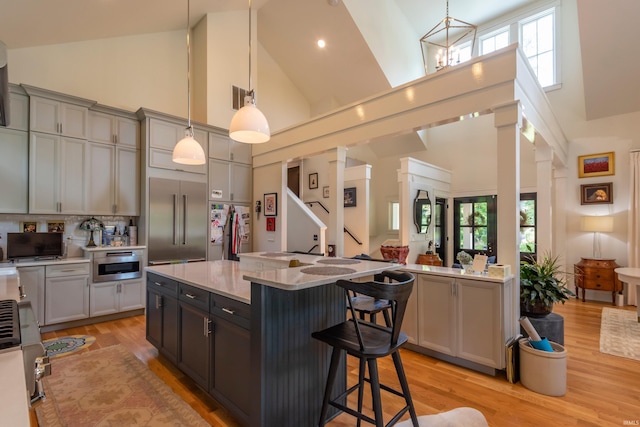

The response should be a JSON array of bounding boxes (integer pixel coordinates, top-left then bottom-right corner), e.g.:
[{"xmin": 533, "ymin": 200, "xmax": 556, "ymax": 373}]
[{"xmin": 573, "ymin": 258, "xmax": 622, "ymax": 305}]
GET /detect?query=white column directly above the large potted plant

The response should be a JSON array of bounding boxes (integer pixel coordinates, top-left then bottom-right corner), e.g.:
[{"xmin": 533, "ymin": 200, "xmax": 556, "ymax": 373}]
[{"xmin": 536, "ymin": 144, "xmax": 553, "ymax": 259}]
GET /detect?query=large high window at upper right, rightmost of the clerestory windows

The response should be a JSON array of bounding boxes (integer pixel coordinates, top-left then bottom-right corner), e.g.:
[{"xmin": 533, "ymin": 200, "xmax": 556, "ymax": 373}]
[{"xmin": 520, "ymin": 9, "xmax": 556, "ymax": 87}]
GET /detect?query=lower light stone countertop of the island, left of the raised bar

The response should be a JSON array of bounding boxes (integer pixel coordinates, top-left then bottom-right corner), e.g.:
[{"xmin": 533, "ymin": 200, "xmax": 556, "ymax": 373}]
[{"xmin": 145, "ymin": 260, "xmax": 251, "ymax": 304}]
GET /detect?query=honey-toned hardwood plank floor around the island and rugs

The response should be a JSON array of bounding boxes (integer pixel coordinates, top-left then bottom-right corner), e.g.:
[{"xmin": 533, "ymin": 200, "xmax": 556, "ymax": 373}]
[{"xmin": 32, "ymin": 299, "xmax": 640, "ymax": 427}]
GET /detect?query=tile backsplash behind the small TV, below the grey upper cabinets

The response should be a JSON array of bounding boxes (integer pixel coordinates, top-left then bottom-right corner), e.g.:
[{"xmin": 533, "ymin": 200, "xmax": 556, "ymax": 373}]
[{"xmin": 0, "ymin": 214, "xmax": 137, "ymax": 260}]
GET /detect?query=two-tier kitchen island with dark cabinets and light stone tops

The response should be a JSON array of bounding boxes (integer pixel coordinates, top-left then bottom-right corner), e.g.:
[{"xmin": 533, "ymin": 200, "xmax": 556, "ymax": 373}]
[{"xmin": 146, "ymin": 253, "xmax": 401, "ymax": 427}]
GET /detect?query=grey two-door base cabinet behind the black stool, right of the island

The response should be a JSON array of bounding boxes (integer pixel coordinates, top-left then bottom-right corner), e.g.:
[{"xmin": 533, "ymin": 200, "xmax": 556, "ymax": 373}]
[{"xmin": 412, "ymin": 274, "xmax": 512, "ymax": 369}]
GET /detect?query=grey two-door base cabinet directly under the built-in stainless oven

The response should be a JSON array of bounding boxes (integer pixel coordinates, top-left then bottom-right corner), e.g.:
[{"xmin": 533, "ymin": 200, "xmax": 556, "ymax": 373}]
[{"xmin": 89, "ymin": 279, "xmax": 145, "ymax": 317}]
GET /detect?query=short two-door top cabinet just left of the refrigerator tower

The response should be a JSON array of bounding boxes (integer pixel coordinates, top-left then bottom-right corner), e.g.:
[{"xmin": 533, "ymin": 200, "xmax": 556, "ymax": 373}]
[{"xmin": 89, "ymin": 111, "xmax": 139, "ymax": 148}]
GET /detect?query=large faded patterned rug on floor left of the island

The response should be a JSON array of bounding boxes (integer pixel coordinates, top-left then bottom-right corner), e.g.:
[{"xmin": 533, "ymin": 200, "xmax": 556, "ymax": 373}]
[{"xmin": 36, "ymin": 345, "xmax": 209, "ymax": 427}]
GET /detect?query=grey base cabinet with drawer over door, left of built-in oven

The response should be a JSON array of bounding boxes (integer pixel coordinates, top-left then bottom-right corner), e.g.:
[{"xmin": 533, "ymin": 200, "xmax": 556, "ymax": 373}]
[{"xmin": 44, "ymin": 263, "xmax": 90, "ymax": 325}]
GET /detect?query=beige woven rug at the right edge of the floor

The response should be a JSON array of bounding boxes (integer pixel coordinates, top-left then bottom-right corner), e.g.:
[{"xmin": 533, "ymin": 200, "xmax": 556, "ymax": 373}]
[{"xmin": 600, "ymin": 307, "xmax": 640, "ymax": 360}]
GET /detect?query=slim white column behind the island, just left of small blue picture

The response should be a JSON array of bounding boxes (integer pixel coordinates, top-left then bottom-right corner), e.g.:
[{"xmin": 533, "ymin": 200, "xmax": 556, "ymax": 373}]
[{"xmin": 324, "ymin": 147, "xmax": 347, "ymax": 257}]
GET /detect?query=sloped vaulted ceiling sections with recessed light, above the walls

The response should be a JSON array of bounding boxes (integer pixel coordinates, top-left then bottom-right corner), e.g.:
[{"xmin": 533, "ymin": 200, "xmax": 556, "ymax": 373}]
[{"xmin": 0, "ymin": 0, "xmax": 640, "ymax": 123}]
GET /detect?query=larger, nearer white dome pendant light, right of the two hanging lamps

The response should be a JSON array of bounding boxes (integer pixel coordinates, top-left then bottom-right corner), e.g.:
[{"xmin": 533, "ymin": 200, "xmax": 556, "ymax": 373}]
[{"xmin": 229, "ymin": 0, "xmax": 271, "ymax": 144}]
